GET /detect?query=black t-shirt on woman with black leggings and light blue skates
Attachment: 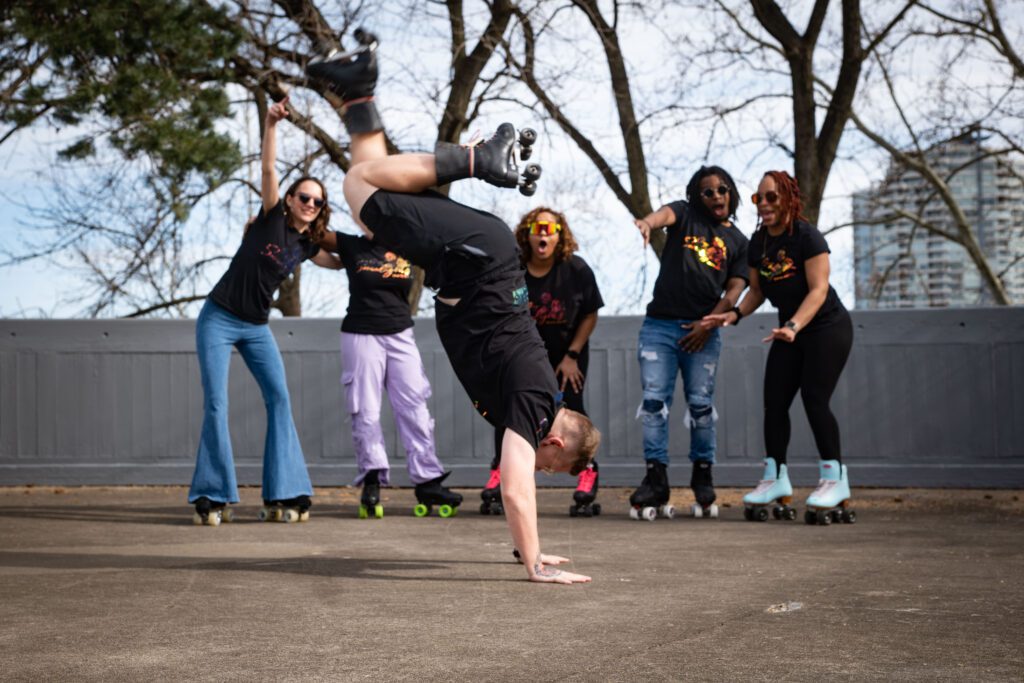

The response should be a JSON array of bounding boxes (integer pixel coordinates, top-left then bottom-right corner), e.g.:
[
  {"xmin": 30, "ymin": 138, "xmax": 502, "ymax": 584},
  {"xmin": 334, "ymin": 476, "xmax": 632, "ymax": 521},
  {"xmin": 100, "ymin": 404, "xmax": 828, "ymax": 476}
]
[{"xmin": 749, "ymin": 220, "xmax": 846, "ymax": 331}]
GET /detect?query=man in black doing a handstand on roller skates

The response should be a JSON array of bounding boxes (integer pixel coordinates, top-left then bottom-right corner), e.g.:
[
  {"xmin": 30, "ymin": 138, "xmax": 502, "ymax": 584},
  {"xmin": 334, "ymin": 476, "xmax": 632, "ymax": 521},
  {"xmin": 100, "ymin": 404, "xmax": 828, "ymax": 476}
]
[{"xmin": 307, "ymin": 32, "xmax": 600, "ymax": 584}]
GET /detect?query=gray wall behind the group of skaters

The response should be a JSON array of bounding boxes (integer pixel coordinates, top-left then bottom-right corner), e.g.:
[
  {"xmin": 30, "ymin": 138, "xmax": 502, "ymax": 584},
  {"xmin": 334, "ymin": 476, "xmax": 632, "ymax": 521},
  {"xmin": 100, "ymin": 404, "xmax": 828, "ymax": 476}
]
[{"xmin": 0, "ymin": 307, "xmax": 1024, "ymax": 487}]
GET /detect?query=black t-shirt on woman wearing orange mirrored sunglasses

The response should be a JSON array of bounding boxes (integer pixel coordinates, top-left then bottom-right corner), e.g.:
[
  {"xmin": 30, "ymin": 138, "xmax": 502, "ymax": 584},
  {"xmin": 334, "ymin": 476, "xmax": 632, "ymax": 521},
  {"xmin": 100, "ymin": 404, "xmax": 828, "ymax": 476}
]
[{"xmin": 526, "ymin": 255, "xmax": 604, "ymax": 366}]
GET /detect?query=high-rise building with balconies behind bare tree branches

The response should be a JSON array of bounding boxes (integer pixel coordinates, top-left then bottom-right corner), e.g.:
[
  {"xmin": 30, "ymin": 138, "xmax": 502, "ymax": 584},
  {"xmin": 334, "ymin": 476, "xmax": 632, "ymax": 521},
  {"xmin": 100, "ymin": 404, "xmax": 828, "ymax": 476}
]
[{"xmin": 853, "ymin": 132, "xmax": 1024, "ymax": 308}]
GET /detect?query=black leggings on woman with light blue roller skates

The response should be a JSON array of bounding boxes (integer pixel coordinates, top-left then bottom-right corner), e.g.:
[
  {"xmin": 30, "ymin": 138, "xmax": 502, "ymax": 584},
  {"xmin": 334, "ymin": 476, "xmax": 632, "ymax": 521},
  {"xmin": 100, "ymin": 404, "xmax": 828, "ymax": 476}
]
[{"xmin": 764, "ymin": 313, "xmax": 853, "ymax": 465}]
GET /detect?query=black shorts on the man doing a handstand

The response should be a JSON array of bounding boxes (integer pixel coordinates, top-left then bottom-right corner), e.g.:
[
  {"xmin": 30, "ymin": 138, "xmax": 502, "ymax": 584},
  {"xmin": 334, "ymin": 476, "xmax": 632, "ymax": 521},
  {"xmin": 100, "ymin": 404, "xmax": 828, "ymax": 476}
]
[{"xmin": 359, "ymin": 189, "xmax": 519, "ymax": 298}]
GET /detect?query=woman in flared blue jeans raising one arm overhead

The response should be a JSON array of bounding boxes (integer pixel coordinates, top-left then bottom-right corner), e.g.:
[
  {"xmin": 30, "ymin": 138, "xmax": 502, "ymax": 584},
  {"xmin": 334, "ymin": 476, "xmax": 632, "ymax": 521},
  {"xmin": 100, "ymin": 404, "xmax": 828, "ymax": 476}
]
[{"xmin": 188, "ymin": 97, "xmax": 340, "ymax": 525}]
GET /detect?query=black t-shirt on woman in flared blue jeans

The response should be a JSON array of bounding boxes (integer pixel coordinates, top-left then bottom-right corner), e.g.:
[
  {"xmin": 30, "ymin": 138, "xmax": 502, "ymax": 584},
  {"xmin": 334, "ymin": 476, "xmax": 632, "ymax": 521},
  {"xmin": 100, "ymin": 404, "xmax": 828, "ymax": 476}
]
[{"xmin": 210, "ymin": 202, "xmax": 319, "ymax": 325}]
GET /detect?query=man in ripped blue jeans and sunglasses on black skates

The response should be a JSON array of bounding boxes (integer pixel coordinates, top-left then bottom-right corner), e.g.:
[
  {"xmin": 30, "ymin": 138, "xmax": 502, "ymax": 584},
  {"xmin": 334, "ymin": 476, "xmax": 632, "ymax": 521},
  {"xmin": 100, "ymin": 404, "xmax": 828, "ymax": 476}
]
[{"xmin": 630, "ymin": 166, "xmax": 748, "ymax": 521}]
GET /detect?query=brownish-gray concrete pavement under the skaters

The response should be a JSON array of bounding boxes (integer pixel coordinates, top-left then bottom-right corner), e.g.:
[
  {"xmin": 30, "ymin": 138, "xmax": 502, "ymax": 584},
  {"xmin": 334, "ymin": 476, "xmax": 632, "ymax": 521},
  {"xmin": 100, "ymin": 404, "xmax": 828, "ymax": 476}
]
[{"xmin": 0, "ymin": 486, "xmax": 1024, "ymax": 681}]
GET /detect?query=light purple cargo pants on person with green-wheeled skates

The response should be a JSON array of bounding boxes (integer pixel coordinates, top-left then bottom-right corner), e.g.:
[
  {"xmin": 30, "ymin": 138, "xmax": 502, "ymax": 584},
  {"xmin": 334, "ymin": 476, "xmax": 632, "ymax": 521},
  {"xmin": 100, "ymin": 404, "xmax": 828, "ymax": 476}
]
[{"xmin": 341, "ymin": 328, "xmax": 444, "ymax": 485}]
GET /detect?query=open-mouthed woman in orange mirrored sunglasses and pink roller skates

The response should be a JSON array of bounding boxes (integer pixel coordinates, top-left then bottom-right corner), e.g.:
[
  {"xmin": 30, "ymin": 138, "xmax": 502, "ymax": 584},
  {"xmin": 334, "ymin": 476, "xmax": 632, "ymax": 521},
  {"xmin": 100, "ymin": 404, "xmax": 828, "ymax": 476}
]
[{"xmin": 480, "ymin": 207, "xmax": 604, "ymax": 517}]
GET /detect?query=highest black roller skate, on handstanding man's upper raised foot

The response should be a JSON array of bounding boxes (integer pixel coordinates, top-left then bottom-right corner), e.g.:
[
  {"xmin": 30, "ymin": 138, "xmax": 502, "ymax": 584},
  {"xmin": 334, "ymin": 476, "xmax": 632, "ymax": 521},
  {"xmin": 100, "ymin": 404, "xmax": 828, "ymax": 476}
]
[{"xmin": 306, "ymin": 29, "xmax": 384, "ymax": 133}]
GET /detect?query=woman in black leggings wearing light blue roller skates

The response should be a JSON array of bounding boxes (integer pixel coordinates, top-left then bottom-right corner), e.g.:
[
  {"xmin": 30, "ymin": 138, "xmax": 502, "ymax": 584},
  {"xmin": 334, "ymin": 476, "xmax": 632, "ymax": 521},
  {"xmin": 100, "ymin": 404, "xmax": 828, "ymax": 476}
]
[{"xmin": 703, "ymin": 171, "xmax": 856, "ymax": 524}]
